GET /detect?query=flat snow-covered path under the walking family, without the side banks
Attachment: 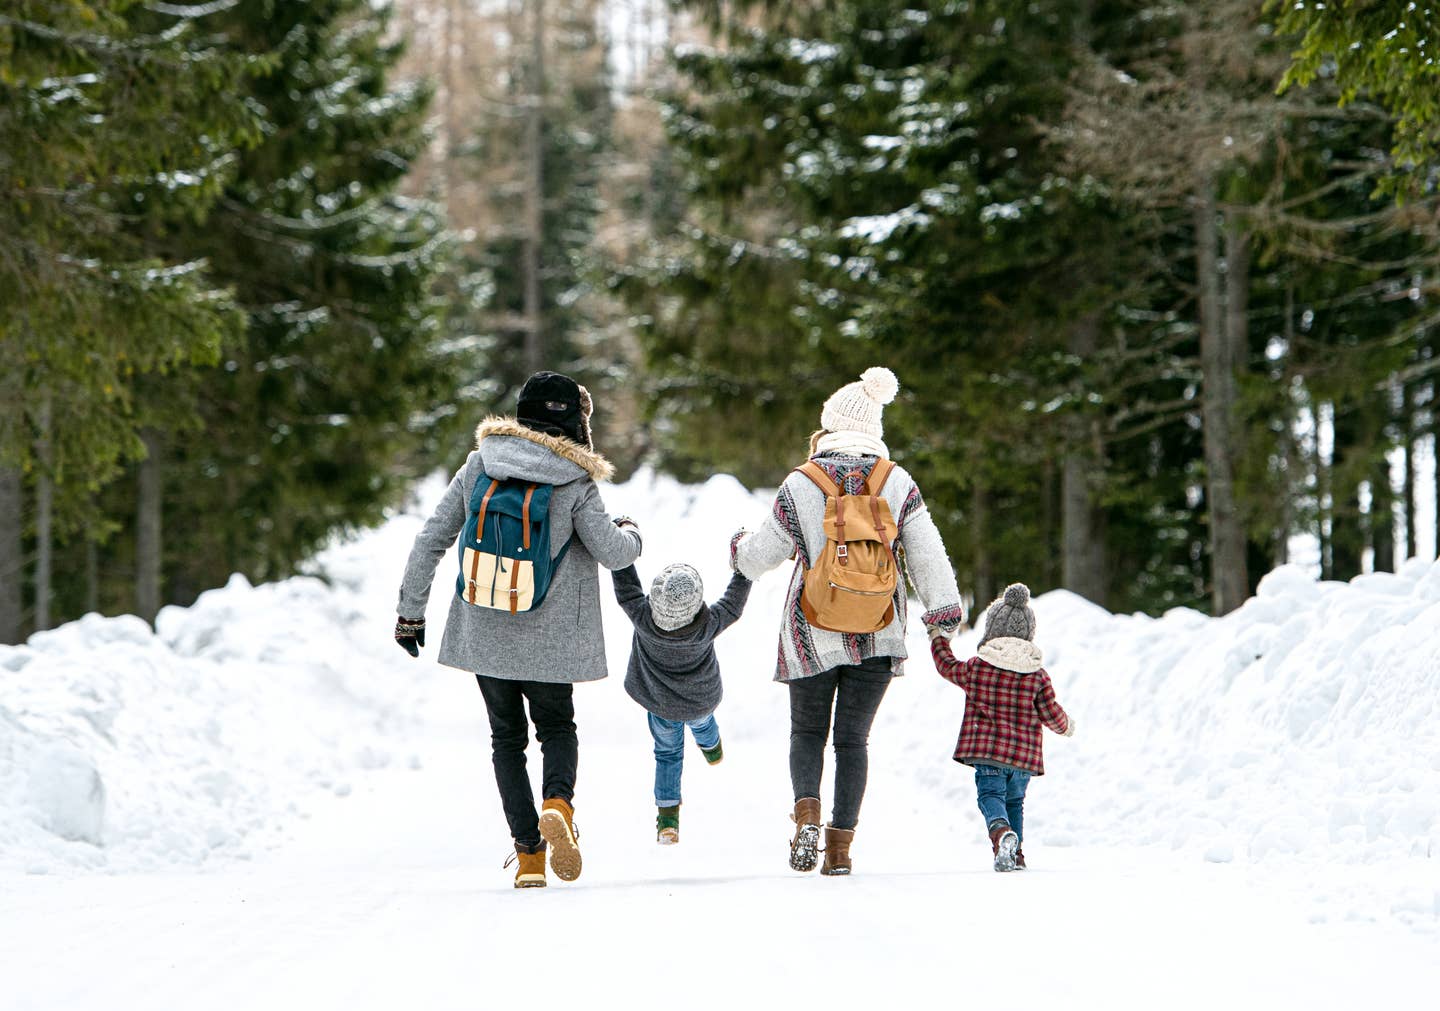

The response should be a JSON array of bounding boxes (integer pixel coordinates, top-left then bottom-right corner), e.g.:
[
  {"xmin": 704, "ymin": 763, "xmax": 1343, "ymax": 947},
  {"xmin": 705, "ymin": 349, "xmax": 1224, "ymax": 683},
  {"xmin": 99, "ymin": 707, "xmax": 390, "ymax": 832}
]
[{"xmin": 0, "ymin": 681, "xmax": 1440, "ymax": 1011}]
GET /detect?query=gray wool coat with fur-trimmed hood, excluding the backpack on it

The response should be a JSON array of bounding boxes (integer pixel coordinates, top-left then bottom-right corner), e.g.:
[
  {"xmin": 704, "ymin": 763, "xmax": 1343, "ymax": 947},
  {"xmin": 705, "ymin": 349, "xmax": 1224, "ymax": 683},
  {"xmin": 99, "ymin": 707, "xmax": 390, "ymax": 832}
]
[{"xmin": 396, "ymin": 418, "xmax": 641, "ymax": 684}]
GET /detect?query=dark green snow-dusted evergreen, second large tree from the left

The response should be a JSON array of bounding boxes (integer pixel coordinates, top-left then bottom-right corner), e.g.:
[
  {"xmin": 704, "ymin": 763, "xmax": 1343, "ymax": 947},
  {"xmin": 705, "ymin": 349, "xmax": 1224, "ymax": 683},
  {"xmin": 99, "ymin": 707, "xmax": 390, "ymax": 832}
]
[{"xmin": 127, "ymin": 0, "xmax": 455, "ymax": 601}]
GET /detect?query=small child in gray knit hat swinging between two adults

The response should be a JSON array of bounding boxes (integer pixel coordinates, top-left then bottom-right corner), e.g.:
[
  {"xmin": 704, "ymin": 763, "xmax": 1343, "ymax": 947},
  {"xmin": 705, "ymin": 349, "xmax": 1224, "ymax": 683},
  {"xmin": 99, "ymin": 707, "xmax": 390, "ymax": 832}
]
[{"xmin": 612, "ymin": 565, "xmax": 750, "ymax": 845}]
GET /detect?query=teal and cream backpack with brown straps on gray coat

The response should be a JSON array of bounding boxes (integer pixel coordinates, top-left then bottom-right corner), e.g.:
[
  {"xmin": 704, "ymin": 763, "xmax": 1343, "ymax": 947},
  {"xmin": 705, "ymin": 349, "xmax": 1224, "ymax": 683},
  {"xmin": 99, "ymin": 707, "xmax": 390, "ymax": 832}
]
[{"xmin": 455, "ymin": 472, "xmax": 570, "ymax": 615}]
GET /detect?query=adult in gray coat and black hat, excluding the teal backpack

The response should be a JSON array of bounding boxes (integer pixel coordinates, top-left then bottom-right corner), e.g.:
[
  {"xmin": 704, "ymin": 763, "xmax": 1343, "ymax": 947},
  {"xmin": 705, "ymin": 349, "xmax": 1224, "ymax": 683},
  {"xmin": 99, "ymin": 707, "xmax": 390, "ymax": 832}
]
[{"xmin": 395, "ymin": 372, "xmax": 641, "ymax": 887}]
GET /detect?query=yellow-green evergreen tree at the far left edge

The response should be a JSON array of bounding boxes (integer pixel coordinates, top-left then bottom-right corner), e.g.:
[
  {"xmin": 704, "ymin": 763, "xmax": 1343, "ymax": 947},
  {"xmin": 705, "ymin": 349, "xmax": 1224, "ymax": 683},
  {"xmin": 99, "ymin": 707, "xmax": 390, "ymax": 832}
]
[{"xmin": 0, "ymin": 0, "xmax": 253, "ymax": 638}]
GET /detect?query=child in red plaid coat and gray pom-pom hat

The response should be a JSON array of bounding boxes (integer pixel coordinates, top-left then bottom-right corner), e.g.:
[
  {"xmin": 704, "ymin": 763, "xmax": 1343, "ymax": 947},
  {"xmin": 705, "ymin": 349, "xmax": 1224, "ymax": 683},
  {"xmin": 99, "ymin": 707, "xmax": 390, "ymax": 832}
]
[{"xmin": 927, "ymin": 583, "xmax": 1076, "ymax": 871}]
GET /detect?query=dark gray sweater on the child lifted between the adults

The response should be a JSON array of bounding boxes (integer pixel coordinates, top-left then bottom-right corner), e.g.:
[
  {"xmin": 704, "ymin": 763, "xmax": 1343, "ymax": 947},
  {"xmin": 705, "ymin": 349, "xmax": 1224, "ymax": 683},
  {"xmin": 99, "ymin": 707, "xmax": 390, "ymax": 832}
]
[{"xmin": 611, "ymin": 566, "xmax": 750, "ymax": 722}]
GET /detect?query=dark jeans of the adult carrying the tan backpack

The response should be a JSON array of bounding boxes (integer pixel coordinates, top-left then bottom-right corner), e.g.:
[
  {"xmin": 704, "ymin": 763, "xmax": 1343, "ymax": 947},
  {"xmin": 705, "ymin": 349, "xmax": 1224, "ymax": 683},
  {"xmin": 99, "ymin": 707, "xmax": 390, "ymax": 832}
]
[{"xmin": 789, "ymin": 657, "xmax": 893, "ymax": 828}]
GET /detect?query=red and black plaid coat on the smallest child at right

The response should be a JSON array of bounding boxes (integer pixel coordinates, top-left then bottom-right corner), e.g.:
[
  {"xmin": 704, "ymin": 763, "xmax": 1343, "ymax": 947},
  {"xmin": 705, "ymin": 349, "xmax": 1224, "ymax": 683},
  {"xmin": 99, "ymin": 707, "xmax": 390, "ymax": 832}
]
[{"xmin": 930, "ymin": 635, "xmax": 1070, "ymax": 776}]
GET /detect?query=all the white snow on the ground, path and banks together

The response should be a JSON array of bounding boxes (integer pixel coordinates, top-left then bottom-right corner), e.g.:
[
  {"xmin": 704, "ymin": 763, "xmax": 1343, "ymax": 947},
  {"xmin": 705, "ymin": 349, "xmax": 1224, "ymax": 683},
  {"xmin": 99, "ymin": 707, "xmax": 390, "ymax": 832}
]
[{"xmin": 0, "ymin": 474, "xmax": 1440, "ymax": 1011}]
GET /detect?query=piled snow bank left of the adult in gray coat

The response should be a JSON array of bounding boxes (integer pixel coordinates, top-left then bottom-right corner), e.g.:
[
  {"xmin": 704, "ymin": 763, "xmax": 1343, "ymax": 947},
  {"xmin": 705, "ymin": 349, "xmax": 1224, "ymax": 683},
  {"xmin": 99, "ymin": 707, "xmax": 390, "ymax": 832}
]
[{"xmin": 0, "ymin": 487, "xmax": 436, "ymax": 873}]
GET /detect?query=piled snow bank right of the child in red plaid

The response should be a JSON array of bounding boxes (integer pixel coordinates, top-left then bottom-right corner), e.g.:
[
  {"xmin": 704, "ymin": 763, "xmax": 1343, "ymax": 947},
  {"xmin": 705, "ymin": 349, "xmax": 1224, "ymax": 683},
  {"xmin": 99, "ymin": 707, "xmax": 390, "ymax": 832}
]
[{"xmin": 1037, "ymin": 563, "xmax": 1440, "ymax": 864}]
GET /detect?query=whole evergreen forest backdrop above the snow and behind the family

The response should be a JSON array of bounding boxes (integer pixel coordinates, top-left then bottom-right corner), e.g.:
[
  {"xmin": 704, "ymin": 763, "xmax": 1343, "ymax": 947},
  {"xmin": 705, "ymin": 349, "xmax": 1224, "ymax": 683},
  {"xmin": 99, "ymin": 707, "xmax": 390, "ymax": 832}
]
[{"xmin": 0, "ymin": 0, "xmax": 1440, "ymax": 642}]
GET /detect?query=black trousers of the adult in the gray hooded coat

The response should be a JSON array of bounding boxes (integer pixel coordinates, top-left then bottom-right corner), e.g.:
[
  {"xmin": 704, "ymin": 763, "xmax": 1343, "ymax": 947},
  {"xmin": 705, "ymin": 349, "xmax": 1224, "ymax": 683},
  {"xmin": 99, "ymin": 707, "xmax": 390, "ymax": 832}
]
[{"xmin": 475, "ymin": 675, "xmax": 580, "ymax": 851}]
